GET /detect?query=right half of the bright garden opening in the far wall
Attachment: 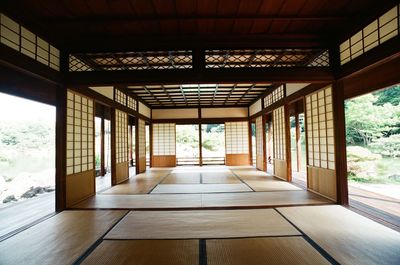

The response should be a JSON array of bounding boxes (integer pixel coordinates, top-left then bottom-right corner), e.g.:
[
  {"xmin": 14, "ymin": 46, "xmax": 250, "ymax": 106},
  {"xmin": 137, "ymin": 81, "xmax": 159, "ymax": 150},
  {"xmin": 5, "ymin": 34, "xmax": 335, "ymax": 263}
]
[{"xmin": 201, "ymin": 123, "xmax": 225, "ymax": 165}]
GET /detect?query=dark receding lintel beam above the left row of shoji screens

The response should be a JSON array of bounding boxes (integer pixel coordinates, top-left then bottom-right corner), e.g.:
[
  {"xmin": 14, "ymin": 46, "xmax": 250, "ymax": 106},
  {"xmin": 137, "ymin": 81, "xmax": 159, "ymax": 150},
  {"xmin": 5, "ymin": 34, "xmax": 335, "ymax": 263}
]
[{"xmin": 71, "ymin": 88, "xmax": 150, "ymax": 122}]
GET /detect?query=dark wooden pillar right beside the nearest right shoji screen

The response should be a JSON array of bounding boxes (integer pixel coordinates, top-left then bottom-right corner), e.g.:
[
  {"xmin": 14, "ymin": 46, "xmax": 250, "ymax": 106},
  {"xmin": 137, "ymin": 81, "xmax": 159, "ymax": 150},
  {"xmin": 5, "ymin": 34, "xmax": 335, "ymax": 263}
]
[{"xmin": 332, "ymin": 81, "xmax": 349, "ymax": 205}]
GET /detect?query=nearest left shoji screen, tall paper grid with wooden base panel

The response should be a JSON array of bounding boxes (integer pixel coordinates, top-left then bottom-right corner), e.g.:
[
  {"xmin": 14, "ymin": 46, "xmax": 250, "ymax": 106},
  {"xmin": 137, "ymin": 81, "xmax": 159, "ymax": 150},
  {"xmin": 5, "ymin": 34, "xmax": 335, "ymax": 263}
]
[{"xmin": 66, "ymin": 90, "xmax": 95, "ymax": 207}]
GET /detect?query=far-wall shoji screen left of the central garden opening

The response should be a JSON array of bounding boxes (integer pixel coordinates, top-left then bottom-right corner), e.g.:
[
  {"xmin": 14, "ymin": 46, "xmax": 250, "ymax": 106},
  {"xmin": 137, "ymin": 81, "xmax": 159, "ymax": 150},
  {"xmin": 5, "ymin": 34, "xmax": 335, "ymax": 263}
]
[{"xmin": 152, "ymin": 123, "xmax": 176, "ymax": 167}]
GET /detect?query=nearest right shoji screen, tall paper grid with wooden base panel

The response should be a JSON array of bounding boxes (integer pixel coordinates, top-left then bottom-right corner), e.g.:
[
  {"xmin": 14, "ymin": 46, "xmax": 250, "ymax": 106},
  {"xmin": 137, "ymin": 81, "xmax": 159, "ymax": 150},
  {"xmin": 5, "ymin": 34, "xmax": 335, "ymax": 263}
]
[{"xmin": 306, "ymin": 86, "xmax": 336, "ymax": 200}]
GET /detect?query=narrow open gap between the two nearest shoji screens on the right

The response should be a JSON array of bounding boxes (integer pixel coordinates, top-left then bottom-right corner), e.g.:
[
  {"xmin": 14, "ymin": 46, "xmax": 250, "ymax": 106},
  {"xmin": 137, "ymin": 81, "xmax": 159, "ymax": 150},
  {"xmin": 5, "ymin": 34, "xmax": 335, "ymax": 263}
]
[{"xmin": 290, "ymin": 100, "xmax": 307, "ymax": 188}]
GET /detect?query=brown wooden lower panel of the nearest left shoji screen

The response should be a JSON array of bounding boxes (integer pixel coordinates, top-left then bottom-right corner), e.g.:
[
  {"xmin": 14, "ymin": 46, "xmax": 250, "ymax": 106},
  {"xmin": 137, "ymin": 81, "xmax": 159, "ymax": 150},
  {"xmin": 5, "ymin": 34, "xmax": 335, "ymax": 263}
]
[{"xmin": 66, "ymin": 170, "xmax": 95, "ymax": 207}]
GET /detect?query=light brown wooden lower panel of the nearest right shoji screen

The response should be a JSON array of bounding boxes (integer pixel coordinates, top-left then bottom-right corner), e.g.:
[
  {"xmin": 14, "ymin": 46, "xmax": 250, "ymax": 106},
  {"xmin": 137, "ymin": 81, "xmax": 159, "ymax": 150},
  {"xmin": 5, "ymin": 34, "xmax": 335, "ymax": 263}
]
[{"xmin": 307, "ymin": 166, "xmax": 337, "ymax": 202}]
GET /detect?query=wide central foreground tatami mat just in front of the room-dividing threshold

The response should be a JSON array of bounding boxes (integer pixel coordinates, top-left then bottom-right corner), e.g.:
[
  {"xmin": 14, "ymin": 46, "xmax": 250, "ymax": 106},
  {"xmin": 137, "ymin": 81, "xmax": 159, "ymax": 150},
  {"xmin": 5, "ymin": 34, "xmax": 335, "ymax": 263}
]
[{"xmin": 105, "ymin": 209, "xmax": 299, "ymax": 239}]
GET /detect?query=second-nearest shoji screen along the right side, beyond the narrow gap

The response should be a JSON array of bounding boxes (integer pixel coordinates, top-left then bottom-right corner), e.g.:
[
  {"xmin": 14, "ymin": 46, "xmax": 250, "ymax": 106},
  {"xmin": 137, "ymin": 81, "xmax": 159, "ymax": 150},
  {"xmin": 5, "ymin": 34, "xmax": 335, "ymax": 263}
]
[{"xmin": 272, "ymin": 107, "xmax": 288, "ymax": 180}]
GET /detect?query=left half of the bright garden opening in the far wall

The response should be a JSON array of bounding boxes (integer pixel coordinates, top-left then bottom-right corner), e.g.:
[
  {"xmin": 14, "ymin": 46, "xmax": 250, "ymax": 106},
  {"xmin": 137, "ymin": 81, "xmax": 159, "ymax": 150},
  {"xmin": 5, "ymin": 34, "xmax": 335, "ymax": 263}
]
[{"xmin": 176, "ymin": 124, "xmax": 200, "ymax": 166}]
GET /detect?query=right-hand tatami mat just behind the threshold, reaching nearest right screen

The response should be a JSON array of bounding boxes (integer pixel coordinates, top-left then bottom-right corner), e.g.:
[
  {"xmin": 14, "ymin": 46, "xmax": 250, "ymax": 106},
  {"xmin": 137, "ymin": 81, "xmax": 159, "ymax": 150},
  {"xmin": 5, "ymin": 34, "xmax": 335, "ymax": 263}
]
[{"xmin": 202, "ymin": 191, "xmax": 332, "ymax": 207}]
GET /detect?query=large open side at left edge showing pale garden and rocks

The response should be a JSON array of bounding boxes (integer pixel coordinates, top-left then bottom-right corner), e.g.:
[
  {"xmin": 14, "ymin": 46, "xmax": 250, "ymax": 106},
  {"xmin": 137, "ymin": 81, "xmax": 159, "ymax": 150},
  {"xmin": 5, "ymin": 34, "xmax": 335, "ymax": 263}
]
[{"xmin": 0, "ymin": 93, "xmax": 56, "ymax": 238}]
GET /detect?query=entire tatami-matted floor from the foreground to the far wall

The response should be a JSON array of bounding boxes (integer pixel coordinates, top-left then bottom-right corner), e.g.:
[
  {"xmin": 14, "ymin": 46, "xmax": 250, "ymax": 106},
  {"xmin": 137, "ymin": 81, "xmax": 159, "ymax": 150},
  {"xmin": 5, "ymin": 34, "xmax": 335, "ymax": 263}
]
[{"xmin": 0, "ymin": 167, "xmax": 400, "ymax": 265}]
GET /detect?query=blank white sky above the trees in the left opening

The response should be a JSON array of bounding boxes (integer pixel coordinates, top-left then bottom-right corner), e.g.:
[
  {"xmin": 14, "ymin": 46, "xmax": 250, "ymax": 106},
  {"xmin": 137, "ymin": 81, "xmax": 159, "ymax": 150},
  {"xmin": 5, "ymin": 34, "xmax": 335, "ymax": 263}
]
[{"xmin": 0, "ymin": 93, "xmax": 56, "ymax": 122}]
